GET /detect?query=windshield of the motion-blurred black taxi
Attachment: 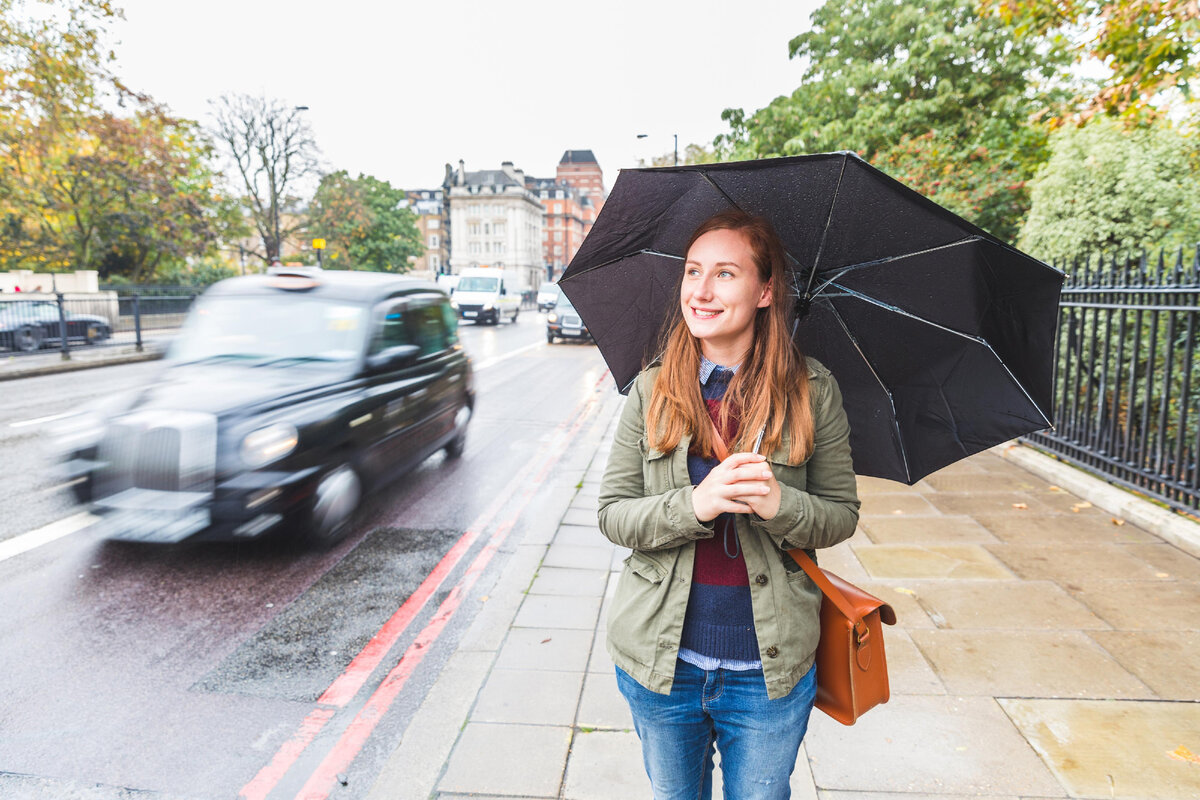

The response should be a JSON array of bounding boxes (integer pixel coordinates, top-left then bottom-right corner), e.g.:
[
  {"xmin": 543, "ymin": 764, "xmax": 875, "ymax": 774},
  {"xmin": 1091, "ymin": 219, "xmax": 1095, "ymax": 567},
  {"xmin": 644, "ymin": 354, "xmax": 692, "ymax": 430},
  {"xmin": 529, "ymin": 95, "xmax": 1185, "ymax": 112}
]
[{"xmin": 168, "ymin": 294, "xmax": 367, "ymax": 369}]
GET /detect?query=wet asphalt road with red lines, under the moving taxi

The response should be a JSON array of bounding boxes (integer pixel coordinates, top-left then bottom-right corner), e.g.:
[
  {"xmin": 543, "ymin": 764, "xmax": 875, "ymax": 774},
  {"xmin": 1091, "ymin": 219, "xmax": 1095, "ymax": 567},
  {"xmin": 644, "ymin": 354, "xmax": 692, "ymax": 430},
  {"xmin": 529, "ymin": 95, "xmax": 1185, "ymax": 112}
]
[{"xmin": 0, "ymin": 313, "xmax": 616, "ymax": 800}]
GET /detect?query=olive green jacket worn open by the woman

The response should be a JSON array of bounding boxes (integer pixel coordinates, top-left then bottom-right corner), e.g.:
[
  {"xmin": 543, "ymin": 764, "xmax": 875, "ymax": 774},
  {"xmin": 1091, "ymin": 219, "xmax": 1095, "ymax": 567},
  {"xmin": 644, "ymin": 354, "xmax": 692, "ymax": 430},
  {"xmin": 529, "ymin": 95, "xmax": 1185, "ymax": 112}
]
[{"xmin": 600, "ymin": 359, "xmax": 859, "ymax": 698}]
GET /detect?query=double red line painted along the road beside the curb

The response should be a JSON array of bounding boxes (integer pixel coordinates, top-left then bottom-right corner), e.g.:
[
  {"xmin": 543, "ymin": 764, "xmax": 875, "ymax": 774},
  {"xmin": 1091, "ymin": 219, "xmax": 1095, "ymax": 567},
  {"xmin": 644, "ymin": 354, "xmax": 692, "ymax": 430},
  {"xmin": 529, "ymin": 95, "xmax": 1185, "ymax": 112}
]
[{"xmin": 238, "ymin": 371, "xmax": 608, "ymax": 800}]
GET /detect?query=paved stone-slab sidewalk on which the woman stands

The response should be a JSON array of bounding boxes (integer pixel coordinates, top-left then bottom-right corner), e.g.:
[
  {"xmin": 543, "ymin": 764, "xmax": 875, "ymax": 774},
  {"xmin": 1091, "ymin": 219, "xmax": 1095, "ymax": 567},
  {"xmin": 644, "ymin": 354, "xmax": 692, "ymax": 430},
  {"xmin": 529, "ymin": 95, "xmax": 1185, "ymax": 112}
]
[{"xmin": 370, "ymin": 398, "xmax": 1200, "ymax": 800}]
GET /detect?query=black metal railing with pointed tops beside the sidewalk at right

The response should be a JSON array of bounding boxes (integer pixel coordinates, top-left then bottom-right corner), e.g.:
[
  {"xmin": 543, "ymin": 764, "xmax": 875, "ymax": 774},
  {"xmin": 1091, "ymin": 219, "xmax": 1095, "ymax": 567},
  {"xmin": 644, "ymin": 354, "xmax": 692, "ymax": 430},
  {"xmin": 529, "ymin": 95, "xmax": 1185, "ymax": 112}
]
[{"xmin": 1028, "ymin": 248, "xmax": 1200, "ymax": 512}]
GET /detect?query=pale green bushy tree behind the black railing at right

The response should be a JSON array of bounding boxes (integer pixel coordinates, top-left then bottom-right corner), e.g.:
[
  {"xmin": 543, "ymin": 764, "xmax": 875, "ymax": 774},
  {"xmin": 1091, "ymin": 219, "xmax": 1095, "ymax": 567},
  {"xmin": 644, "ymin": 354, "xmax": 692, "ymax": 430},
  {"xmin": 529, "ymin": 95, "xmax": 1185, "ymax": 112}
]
[{"xmin": 1019, "ymin": 116, "xmax": 1200, "ymax": 261}]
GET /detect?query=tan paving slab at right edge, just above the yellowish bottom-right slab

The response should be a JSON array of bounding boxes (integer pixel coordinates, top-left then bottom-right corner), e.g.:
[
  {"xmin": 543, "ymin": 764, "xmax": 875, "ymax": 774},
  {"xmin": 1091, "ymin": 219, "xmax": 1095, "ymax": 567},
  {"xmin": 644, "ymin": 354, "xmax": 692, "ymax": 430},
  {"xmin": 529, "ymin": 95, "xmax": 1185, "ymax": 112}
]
[{"xmin": 1088, "ymin": 631, "xmax": 1200, "ymax": 700}]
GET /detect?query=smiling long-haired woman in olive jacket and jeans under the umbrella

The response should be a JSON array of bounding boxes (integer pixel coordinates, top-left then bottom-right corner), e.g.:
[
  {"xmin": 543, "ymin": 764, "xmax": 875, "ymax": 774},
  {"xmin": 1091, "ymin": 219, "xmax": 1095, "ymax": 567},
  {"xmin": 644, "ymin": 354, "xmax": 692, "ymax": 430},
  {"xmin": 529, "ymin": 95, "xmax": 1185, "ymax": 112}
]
[{"xmin": 600, "ymin": 211, "xmax": 859, "ymax": 800}]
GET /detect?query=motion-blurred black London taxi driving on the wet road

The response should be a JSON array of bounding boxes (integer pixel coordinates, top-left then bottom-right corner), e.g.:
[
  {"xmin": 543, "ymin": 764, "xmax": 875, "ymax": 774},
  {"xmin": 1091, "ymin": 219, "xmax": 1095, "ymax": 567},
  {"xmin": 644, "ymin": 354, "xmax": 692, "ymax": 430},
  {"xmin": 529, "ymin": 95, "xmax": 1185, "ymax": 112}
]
[{"xmin": 52, "ymin": 269, "xmax": 475, "ymax": 545}]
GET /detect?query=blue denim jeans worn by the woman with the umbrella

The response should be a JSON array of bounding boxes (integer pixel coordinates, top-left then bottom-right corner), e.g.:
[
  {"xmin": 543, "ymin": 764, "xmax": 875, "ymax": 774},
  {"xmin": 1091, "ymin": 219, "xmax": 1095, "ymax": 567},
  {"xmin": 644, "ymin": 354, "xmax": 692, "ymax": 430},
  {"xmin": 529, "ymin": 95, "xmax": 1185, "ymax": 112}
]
[{"xmin": 617, "ymin": 661, "xmax": 817, "ymax": 800}]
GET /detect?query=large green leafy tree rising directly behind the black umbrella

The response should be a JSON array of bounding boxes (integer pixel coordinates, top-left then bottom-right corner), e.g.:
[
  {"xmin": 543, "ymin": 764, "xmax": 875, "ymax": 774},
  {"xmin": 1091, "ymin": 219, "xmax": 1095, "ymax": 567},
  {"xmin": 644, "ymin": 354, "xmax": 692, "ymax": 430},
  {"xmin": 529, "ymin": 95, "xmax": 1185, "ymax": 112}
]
[{"xmin": 716, "ymin": 0, "xmax": 1068, "ymax": 239}]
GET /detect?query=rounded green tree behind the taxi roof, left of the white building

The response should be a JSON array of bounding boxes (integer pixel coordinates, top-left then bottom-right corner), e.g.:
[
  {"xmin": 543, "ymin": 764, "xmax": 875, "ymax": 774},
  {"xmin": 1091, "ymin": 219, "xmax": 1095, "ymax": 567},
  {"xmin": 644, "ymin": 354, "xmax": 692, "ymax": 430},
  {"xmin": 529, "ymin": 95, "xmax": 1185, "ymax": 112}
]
[{"xmin": 310, "ymin": 170, "xmax": 425, "ymax": 272}]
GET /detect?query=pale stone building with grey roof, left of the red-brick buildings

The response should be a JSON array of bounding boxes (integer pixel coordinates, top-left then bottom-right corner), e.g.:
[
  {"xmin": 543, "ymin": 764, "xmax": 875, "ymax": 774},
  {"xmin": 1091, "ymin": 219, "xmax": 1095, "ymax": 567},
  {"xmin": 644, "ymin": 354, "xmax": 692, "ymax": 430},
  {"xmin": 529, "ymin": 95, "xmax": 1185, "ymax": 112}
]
[{"xmin": 443, "ymin": 161, "xmax": 545, "ymax": 289}]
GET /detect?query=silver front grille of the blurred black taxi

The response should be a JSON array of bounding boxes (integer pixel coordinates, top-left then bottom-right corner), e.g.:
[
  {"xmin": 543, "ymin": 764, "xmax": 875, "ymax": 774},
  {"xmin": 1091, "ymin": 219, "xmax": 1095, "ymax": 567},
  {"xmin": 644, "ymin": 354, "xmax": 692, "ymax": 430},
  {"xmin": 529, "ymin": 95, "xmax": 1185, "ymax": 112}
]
[{"xmin": 96, "ymin": 411, "xmax": 217, "ymax": 497}]
